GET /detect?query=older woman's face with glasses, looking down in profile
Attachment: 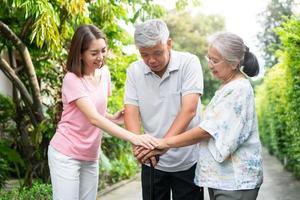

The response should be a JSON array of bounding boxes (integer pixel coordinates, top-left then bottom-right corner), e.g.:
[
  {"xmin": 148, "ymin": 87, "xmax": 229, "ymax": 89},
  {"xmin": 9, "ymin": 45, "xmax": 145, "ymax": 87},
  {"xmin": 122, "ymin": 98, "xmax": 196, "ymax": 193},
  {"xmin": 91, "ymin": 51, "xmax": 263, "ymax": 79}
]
[{"xmin": 207, "ymin": 46, "xmax": 236, "ymax": 82}]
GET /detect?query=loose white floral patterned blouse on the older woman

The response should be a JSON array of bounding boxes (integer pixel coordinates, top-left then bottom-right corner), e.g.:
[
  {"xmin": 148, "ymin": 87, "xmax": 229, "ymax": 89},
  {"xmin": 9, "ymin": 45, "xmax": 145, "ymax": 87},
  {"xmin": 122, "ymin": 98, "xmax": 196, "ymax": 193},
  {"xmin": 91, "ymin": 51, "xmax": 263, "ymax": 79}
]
[{"xmin": 195, "ymin": 79, "xmax": 263, "ymax": 190}]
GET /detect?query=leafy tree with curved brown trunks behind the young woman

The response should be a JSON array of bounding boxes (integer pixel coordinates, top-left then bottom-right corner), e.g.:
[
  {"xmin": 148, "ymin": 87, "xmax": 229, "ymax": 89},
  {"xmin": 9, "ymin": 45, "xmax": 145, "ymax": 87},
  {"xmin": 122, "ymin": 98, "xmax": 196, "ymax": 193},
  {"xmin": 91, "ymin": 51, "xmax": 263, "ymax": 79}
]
[{"xmin": 0, "ymin": 0, "xmax": 164, "ymax": 185}]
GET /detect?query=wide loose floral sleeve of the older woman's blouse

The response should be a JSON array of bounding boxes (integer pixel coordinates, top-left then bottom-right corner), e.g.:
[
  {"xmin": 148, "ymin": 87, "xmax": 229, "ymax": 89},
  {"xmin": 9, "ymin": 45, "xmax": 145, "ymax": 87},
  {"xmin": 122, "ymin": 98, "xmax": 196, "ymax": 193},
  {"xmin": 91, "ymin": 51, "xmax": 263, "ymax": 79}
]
[{"xmin": 200, "ymin": 88, "xmax": 252, "ymax": 162}]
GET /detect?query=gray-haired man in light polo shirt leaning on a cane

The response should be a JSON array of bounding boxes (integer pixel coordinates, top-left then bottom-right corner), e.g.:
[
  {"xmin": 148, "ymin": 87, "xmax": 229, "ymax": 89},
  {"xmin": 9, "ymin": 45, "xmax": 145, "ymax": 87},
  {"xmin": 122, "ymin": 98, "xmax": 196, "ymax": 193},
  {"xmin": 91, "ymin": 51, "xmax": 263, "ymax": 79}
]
[{"xmin": 125, "ymin": 20, "xmax": 203, "ymax": 200}]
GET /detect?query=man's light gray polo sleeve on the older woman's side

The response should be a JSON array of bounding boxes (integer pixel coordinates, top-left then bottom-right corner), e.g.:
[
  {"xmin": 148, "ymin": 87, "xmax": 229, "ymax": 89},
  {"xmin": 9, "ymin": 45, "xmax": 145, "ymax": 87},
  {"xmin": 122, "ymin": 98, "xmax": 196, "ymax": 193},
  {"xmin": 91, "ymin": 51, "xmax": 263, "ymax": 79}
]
[{"xmin": 181, "ymin": 55, "xmax": 203, "ymax": 96}]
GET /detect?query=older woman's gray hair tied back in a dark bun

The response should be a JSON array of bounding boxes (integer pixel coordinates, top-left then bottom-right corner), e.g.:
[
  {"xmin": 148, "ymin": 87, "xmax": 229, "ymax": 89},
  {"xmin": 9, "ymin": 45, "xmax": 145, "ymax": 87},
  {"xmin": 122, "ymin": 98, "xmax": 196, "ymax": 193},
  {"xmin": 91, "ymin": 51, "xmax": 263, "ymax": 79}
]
[{"xmin": 209, "ymin": 32, "xmax": 259, "ymax": 77}]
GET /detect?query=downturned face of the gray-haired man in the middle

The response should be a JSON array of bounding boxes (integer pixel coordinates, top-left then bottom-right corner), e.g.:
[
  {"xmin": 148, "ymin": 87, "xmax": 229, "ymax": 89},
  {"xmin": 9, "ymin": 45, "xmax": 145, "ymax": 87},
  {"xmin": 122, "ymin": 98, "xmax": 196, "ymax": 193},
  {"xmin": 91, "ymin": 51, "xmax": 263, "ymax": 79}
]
[{"xmin": 139, "ymin": 39, "xmax": 172, "ymax": 75}]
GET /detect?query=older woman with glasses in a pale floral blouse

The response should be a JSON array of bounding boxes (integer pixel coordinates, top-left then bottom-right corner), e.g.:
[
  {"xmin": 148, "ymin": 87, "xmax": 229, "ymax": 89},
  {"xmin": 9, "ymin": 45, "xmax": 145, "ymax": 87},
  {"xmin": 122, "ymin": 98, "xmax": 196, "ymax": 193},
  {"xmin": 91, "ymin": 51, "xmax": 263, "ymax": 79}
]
[{"xmin": 144, "ymin": 32, "xmax": 263, "ymax": 200}]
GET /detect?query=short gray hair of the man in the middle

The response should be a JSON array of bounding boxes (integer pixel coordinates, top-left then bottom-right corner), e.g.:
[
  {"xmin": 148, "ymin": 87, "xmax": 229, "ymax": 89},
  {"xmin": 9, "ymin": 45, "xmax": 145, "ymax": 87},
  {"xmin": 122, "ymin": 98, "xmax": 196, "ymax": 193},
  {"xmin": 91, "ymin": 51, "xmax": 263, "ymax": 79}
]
[{"xmin": 134, "ymin": 19, "xmax": 170, "ymax": 48}]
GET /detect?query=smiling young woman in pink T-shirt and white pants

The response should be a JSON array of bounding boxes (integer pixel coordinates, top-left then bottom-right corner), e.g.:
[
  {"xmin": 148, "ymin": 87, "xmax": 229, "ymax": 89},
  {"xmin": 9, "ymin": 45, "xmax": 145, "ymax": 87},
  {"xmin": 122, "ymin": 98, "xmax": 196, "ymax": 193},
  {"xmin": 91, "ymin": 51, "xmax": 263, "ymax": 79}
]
[{"xmin": 48, "ymin": 25, "xmax": 157, "ymax": 200}]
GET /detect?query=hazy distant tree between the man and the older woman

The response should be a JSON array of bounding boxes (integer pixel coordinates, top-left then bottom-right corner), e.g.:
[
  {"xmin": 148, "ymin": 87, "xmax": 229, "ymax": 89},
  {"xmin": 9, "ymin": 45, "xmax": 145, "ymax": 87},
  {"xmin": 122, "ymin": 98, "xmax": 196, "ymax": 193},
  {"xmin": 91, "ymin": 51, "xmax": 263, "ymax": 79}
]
[{"xmin": 165, "ymin": 11, "xmax": 224, "ymax": 103}]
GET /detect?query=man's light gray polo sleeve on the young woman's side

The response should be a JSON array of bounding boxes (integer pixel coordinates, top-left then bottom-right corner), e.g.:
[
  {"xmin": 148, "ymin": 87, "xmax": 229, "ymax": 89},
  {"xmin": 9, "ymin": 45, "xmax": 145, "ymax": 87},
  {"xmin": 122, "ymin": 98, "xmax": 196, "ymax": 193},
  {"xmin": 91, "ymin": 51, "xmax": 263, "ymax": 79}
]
[{"xmin": 124, "ymin": 68, "xmax": 138, "ymax": 106}]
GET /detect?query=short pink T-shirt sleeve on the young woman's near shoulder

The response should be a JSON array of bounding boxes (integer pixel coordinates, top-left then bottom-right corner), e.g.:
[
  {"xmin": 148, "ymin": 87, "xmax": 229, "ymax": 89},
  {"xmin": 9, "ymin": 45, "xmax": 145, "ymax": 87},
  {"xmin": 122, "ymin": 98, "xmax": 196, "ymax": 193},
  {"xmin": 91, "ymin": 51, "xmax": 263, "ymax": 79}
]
[{"xmin": 62, "ymin": 72, "xmax": 88, "ymax": 103}]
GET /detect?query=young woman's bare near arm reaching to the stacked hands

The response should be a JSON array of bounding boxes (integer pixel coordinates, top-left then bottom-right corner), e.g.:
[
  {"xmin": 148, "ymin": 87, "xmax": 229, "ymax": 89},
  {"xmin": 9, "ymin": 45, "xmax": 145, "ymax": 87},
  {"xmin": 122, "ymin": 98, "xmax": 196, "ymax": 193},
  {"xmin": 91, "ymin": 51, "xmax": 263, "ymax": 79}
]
[{"xmin": 75, "ymin": 97, "xmax": 158, "ymax": 149}]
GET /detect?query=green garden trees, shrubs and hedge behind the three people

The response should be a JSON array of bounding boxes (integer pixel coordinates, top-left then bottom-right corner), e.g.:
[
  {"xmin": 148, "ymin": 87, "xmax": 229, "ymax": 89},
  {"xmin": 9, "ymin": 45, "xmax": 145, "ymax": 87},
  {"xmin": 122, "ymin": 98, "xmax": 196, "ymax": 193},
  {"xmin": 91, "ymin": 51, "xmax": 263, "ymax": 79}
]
[{"xmin": 0, "ymin": 0, "xmax": 300, "ymax": 199}]
